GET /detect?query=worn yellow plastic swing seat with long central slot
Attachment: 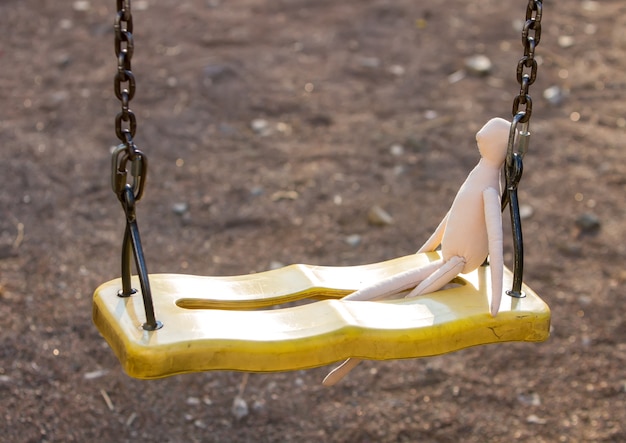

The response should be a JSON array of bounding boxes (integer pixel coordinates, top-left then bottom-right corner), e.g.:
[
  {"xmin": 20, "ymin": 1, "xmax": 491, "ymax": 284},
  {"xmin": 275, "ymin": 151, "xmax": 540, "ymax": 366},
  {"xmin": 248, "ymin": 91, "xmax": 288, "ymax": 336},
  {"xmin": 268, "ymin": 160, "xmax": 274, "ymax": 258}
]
[{"xmin": 93, "ymin": 252, "xmax": 550, "ymax": 379}]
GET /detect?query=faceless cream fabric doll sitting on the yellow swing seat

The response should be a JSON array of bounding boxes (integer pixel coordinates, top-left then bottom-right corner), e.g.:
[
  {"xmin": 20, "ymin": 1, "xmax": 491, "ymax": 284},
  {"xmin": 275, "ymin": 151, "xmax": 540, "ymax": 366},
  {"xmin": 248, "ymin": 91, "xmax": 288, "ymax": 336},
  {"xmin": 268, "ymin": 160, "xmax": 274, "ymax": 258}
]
[{"xmin": 323, "ymin": 118, "xmax": 511, "ymax": 386}]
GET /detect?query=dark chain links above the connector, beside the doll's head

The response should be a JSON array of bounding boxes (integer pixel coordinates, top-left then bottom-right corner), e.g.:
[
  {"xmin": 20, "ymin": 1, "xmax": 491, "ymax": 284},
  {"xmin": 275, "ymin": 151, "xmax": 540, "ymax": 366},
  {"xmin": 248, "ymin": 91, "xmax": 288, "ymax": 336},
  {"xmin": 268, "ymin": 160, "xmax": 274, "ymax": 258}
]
[{"xmin": 513, "ymin": 0, "xmax": 543, "ymax": 123}]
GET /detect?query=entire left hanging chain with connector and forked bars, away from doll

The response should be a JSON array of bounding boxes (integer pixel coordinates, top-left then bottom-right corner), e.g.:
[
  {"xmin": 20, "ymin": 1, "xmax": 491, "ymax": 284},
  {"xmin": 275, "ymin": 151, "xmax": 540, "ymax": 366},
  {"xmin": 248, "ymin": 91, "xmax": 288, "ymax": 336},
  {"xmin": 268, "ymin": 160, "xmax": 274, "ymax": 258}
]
[{"xmin": 111, "ymin": 0, "xmax": 163, "ymax": 331}]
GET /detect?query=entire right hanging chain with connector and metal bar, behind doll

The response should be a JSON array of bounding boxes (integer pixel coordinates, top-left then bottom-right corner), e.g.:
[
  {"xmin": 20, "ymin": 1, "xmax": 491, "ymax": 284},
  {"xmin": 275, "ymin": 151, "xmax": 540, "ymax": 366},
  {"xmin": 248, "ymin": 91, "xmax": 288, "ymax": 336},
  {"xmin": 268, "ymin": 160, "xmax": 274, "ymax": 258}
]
[{"xmin": 502, "ymin": 0, "xmax": 543, "ymax": 298}]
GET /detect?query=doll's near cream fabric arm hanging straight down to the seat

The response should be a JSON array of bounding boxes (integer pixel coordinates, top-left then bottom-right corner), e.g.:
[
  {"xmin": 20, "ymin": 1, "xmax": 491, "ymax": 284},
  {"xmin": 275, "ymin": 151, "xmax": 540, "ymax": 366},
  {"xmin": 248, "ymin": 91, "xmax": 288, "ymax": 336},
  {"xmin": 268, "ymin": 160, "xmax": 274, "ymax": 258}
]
[{"xmin": 483, "ymin": 188, "xmax": 504, "ymax": 317}]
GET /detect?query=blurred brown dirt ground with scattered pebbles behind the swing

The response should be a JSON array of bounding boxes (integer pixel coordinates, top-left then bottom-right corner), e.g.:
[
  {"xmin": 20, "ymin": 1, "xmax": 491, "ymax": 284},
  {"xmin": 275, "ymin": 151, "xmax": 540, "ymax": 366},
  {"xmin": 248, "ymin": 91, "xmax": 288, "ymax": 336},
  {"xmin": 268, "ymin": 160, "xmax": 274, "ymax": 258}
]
[{"xmin": 0, "ymin": 0, "xmax": 626, "ymax": 442}]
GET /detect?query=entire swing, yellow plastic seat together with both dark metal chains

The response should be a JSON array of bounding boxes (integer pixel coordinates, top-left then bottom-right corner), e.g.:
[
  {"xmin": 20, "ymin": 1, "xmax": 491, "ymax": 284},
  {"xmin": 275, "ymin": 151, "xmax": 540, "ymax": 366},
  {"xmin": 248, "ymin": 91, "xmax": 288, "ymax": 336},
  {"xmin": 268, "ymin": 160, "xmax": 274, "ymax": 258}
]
[{"xmin": 93, "ymin": 0, "xmax": 550, "ymax": 379}]
